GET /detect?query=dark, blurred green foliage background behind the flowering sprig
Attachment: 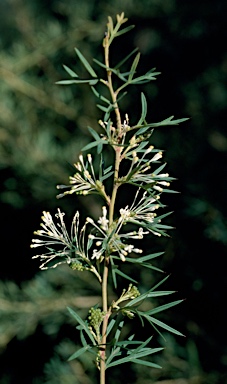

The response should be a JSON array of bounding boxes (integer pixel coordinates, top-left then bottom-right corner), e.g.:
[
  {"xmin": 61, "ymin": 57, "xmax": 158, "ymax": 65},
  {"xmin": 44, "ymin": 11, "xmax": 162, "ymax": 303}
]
[{"xmin": 0, "ymin": 0, "xmax": 227, "ymax": 384}]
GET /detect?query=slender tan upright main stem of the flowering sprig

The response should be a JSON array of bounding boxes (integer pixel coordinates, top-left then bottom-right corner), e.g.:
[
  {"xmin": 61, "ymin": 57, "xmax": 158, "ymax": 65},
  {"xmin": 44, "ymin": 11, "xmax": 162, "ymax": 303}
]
[{"xmin": 100, "ymin": 32, "xmax": 121, "ymax": 384}]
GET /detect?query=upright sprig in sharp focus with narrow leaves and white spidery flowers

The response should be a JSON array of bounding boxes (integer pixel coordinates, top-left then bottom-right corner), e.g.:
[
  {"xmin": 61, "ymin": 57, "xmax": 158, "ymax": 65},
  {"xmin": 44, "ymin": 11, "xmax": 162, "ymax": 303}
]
[{"xmin": 31, "ymin": 13, "xmax": 187, "ymax": 384}]
